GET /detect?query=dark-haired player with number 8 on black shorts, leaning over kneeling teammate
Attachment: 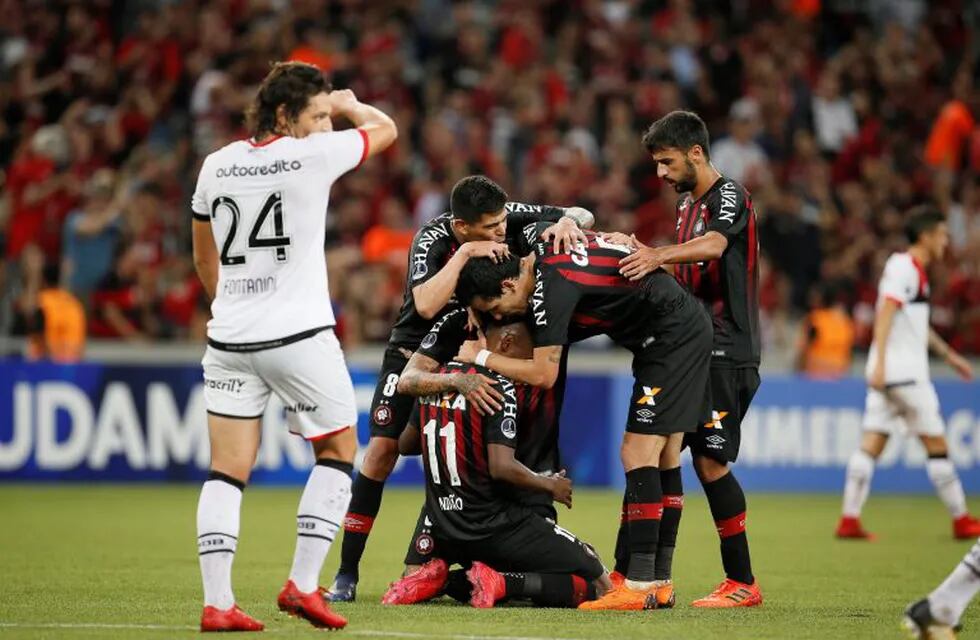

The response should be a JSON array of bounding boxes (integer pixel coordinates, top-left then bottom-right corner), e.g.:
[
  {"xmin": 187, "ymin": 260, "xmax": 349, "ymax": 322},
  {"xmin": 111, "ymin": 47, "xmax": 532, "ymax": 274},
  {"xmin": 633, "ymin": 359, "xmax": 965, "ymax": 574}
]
[{"xmin": 330, "ymin": 176, "xmax": 593, "ymax": 602}]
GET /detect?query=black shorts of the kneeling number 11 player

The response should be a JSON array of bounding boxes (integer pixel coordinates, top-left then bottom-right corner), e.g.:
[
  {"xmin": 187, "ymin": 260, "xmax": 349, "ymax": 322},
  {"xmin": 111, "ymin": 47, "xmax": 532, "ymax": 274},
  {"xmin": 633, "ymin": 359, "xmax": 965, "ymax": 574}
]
[{"xmin": 432, "ymin": 509, "xmax": 605, "ymax": 581}]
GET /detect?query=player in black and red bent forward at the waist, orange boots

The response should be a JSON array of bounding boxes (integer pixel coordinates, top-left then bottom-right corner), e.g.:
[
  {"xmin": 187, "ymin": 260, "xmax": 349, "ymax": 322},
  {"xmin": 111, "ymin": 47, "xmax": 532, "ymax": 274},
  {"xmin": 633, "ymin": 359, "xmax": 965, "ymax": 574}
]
[{"xmin": 456, "ymin": 225, "xmax": 711, "ymax": 610}]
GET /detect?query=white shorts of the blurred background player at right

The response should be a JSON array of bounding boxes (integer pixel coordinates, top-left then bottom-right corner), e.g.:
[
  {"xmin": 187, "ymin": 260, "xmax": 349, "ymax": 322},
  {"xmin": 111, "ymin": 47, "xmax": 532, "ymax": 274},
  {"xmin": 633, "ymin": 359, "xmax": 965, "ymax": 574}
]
[{"xmin": 863, "ymin": 382, "xmax": 946, "ymax": 436}]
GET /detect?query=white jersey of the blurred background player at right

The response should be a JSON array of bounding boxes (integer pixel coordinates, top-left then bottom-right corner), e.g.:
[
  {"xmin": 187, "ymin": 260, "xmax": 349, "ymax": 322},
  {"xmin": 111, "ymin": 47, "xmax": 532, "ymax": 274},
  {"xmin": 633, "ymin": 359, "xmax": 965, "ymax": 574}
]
[{"xmin": 867, "ymin": 253, "xmax": 929, "ymax": 385}]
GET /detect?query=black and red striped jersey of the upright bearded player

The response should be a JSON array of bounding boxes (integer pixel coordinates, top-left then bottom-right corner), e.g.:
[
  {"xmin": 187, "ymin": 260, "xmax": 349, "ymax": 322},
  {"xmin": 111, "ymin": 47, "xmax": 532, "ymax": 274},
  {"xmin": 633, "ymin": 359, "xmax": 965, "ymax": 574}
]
[{"xmin": 674, "ymin": 176, "xmax": 761, "ymax": 367}]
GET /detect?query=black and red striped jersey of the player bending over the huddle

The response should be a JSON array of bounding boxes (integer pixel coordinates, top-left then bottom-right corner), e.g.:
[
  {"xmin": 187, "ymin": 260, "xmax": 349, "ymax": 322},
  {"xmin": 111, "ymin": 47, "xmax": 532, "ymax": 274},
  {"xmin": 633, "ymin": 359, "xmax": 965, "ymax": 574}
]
[{"xmin": 524, "ymin": 224, "xmax": 695, "ymax": 352}]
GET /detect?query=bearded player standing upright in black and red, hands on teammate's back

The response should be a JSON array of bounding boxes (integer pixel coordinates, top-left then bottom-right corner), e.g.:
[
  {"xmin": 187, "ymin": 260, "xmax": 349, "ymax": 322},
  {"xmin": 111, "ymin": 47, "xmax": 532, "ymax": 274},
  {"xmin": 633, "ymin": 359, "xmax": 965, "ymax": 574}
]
[{"xmin": 622, "ymin": 111, "xmax": 762, "ymax": 608}]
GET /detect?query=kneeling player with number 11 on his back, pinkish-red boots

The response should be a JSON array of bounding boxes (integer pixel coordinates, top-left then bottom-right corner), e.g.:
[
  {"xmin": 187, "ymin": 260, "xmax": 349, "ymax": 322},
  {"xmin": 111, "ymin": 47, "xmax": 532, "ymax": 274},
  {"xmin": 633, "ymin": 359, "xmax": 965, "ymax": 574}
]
[{"xmin": 385, "ymin": 362, "xmax": 610, "ymax": 608}]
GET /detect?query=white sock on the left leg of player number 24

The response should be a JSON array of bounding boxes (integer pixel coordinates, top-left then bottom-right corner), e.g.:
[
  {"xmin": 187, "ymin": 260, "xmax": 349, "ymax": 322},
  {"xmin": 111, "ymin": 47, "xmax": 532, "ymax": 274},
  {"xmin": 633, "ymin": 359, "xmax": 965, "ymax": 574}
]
[{"xmin": 197, "ymin": 472, "xmax": 244, "ymax": 610}]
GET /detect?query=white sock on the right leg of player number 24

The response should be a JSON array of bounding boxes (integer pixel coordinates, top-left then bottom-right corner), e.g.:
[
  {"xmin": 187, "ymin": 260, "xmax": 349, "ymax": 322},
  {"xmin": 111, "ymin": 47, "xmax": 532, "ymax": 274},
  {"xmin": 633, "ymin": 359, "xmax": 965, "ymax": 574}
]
[{"xmin": 289, "ymin": 460, "xmax": 352, "ymax": 593}]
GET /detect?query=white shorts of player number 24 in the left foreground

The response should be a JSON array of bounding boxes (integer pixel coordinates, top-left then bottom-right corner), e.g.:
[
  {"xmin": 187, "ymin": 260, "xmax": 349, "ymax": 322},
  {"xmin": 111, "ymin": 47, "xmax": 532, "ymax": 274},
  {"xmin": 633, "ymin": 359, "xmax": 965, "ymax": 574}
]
[{"xmin": 201, "ymin": 329, "xmax": 357, "ymax": 440}]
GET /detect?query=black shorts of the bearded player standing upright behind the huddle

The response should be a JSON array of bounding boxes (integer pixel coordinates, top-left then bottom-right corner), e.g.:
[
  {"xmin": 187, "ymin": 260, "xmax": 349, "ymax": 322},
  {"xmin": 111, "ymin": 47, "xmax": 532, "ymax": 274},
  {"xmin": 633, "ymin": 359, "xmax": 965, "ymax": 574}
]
[{"xmin": 684, "ymin": 367, "xmax": 760, "ymax": 464}]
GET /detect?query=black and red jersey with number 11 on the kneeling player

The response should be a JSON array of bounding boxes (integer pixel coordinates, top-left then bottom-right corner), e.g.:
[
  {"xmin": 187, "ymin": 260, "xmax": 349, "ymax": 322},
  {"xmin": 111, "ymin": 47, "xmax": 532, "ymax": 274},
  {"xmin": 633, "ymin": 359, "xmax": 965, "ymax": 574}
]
[{"xmin": 418, "ymin": 362, "xmax": 521, "ymax": 541}]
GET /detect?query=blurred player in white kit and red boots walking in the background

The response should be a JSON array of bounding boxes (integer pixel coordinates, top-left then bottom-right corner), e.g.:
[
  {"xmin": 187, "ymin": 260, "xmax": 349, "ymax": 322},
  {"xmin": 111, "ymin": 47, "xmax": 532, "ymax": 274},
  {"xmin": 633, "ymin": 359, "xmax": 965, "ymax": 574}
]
[{"xmin": 837, "ymin": 207, "xmax": 980, "ymax": 540}]
